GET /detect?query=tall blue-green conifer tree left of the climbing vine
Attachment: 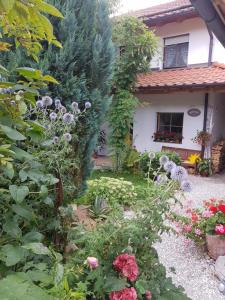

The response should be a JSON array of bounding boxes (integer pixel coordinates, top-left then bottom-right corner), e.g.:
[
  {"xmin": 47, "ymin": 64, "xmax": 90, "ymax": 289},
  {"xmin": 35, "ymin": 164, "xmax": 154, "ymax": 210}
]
[{"xmin": 39, "ymin": 0, "xmax": 114, "ymax": 192}]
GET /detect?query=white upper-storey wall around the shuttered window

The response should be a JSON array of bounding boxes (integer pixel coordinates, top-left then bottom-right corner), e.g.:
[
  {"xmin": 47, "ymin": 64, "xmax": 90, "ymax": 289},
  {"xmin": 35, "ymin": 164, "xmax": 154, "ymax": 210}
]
[{"xmin": 151, "ymin": 18, "xmax": 225, "ymax": 68}]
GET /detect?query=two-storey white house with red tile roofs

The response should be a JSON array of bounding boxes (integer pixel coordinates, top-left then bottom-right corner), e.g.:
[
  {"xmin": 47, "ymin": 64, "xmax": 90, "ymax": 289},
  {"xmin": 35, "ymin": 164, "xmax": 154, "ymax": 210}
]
[{"xmin": 132, "ymin": 0, "xmax": 225, "ymax": 162}]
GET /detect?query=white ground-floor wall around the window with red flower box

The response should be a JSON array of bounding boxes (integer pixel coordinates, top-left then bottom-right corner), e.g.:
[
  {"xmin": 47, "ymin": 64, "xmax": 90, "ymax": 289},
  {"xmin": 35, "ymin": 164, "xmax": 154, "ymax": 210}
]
[{"xmin": 133, "ymin": 93, "xmax": 204, "ymax": 152}]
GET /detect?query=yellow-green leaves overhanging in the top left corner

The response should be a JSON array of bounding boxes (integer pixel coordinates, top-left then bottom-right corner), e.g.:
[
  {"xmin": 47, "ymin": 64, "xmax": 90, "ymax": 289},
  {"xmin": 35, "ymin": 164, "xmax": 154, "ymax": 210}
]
[{"xmin": 0, "ymin": 0, "xmax": 63, "ymax": 60}]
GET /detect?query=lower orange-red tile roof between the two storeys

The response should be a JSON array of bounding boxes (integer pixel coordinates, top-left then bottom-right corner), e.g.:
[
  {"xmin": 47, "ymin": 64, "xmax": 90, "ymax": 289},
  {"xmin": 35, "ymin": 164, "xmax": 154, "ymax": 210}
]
[{"xmin": 136, "ymin": 63, "xmax": 225, "ymax": 92}]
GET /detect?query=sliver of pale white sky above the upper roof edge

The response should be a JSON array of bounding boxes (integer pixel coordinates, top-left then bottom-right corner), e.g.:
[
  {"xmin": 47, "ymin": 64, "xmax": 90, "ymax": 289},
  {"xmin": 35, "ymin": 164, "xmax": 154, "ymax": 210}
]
[{"xmin": 119, "ymin": 0, "xmax": 172, "ymax": 13}]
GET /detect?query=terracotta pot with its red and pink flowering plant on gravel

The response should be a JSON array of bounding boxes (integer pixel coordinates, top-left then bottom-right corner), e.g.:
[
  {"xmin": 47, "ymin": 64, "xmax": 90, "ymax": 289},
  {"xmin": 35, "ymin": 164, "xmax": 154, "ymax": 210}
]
[{"xmin": 173, "ymin": 199, "xmax": 225, "ymax": 260}]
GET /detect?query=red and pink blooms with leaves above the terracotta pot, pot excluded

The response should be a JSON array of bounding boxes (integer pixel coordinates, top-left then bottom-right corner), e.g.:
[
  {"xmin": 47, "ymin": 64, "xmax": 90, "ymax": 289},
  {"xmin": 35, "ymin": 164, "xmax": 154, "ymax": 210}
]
[{"xmin": 171, "ymin": 199, "xmax": 225, "ymax": 244}]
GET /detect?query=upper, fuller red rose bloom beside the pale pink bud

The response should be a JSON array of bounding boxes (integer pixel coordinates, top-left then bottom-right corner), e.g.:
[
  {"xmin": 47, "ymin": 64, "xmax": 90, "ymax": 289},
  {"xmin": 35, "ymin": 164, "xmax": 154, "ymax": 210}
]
[{"xmin": 113, "ymin": 253, "xmax": 138, "ymax": 282}]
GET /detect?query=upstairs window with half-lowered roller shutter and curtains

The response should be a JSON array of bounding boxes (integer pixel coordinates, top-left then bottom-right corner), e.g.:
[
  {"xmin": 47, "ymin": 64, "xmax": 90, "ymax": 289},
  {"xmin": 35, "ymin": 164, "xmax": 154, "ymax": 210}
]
[{"xmin": 163, "ymin": 34, "xmax": 189, "ymax": 69}]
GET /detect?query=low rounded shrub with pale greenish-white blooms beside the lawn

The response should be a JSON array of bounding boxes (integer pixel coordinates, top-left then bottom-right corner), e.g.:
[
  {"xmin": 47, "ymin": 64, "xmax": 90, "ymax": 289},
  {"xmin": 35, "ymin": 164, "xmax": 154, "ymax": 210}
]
[{"xmin": 86, "ymin": 177, "xmax": 137, "ymax": 206}]
